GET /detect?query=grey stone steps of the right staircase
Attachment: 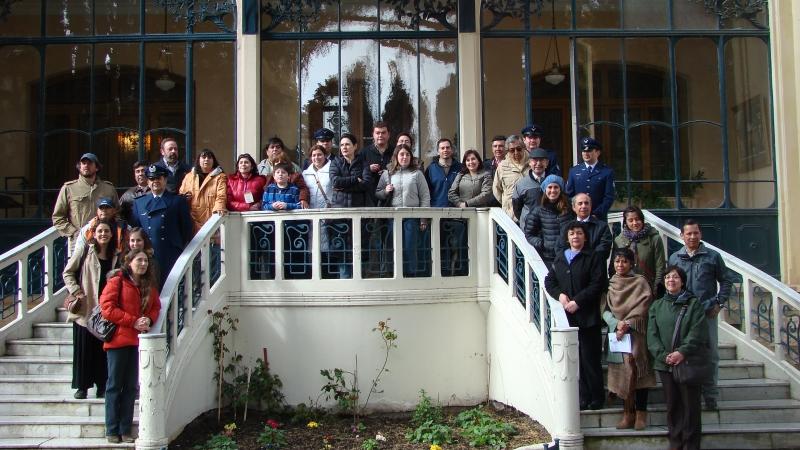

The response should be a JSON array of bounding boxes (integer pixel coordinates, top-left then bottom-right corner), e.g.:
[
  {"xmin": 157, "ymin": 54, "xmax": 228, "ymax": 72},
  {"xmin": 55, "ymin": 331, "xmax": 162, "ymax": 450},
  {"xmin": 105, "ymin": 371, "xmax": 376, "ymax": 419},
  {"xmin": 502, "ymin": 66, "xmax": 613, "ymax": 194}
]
[{"xmin": 581, "ymin": 343, "xmax": 800, "ymax": 450}]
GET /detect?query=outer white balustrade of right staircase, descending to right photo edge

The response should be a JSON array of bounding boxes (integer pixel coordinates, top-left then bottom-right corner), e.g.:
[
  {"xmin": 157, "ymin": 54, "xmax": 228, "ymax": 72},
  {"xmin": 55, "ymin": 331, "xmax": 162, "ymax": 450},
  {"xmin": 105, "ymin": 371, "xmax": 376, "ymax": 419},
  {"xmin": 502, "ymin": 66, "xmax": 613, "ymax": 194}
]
[{"xmin": 609, "ymin": 211, "xmax": 800, "ymax": 390}]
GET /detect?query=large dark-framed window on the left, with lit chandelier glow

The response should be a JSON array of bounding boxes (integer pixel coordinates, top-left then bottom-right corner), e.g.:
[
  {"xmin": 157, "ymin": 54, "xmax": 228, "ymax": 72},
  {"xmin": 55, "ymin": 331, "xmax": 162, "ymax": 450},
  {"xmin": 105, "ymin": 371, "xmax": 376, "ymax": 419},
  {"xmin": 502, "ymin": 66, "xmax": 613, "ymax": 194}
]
[{"xmin": 0, "ymin": 0, "xmax": 236, "ymax": 218}]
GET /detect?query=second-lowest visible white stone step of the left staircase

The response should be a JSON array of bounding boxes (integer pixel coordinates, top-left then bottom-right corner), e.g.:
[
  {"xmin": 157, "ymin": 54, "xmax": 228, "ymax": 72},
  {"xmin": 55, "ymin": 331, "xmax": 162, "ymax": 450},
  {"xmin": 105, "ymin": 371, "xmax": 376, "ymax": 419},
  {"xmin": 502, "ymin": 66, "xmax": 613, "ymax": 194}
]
[{"xmin": 0, "ymin": 416, "xmax": 138, "ymax": 438}]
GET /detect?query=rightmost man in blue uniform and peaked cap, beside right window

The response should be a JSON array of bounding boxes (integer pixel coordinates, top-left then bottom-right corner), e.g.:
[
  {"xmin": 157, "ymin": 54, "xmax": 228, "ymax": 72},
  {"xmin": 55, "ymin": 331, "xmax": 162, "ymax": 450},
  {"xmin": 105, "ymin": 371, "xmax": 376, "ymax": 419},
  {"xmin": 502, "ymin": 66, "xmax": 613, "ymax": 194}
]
[{"xmin": 565, "ymin": 137, "xmax": 614, "ymax": 222}]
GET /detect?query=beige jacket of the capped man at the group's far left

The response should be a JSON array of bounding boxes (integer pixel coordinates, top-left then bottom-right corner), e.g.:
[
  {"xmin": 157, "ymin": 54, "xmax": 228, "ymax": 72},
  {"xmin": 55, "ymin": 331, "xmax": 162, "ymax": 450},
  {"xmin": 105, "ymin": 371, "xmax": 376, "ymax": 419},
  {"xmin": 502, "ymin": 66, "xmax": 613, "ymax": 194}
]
[{"xmin": 53, "ymin": 176, "xmax": 119, "ymax": 251}]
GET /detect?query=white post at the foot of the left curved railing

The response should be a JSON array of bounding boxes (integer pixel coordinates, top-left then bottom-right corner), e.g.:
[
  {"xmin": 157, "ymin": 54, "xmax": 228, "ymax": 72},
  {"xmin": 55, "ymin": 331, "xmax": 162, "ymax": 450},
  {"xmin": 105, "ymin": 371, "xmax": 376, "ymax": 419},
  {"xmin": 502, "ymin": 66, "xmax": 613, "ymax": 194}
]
[{"xmin": 136, "ymin": 333, "xmax": 169, "ymax": 450}]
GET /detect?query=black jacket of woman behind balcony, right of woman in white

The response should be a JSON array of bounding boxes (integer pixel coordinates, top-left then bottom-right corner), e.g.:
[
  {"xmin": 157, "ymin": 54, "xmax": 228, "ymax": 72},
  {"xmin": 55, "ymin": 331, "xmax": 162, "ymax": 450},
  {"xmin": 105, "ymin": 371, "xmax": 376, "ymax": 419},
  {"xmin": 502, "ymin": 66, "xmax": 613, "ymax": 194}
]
[{"xmin": 330, "ymin": 154, "xmax": 375, "ymax": 208}]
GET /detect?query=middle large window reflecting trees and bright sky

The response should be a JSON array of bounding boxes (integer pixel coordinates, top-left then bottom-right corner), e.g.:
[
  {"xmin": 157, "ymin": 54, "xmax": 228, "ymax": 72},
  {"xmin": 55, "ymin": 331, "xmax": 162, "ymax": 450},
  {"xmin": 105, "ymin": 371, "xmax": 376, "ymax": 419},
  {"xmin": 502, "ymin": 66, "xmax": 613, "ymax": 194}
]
[{"xmin": 260, "ymin": 0, "xmax": 458, "ymax": 161}]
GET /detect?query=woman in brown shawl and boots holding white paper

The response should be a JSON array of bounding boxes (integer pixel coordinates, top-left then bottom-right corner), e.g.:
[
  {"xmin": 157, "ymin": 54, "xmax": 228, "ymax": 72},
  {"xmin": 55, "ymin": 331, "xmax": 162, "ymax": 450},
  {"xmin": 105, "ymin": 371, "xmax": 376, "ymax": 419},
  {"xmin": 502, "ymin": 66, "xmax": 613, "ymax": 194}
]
[{"xmin": 603, "ymin": 248, "xmax": 656, "ymax": 430}]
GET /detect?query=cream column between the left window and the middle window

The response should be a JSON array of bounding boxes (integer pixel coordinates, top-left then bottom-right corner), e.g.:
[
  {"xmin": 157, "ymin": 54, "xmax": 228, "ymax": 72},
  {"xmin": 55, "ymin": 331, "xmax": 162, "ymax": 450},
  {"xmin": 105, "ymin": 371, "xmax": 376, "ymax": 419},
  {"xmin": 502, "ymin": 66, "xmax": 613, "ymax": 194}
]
[{"xmin": 236, "ymin": 0, "xmax": 261, "ymax": 161}]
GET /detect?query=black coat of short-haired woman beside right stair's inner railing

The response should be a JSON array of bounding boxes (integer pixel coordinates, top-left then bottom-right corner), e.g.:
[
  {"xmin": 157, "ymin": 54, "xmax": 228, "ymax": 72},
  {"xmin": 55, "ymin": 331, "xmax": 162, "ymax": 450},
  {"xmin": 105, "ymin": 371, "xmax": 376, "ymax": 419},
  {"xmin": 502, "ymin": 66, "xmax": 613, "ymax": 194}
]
[{"xmin": 544, "ymin": 247, "xmax": 608, "ymax": 328}]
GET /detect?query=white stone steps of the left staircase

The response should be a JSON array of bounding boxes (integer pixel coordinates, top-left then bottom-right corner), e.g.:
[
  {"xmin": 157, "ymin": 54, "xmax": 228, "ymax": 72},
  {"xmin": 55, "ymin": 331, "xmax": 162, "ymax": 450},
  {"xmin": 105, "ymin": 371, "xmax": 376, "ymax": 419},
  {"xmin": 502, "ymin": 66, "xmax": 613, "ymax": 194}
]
[{"xmin": 0, "ymin": 308, "xmax": 138, "ymax": 449}]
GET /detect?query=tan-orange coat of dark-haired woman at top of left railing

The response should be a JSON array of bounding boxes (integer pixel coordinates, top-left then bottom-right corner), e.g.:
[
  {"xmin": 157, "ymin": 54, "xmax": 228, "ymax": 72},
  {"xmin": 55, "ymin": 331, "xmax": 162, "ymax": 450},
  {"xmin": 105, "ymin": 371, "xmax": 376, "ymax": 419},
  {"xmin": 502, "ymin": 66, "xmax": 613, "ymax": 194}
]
[{"xmin": 179, "ymin": 167, "xmax": 228, "ymax": 233}]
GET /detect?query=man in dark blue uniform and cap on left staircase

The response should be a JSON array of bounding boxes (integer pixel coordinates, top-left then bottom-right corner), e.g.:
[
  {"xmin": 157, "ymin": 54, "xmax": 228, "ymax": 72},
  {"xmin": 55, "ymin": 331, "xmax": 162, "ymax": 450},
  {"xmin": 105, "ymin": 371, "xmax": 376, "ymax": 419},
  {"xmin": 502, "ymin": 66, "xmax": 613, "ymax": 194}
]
[{"xmin": 131, "ymin": 164, "xmax": 194, "ymax": 289}]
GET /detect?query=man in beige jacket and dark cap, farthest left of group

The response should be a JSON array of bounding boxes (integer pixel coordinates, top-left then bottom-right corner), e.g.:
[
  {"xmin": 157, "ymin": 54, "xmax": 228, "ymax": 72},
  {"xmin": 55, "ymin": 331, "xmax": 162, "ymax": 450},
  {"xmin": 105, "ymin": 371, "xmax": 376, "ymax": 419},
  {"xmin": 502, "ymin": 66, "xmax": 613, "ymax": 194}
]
[{"xmin": 52, "ymin": 153, "xmax": 119, "ymax": 255}]
